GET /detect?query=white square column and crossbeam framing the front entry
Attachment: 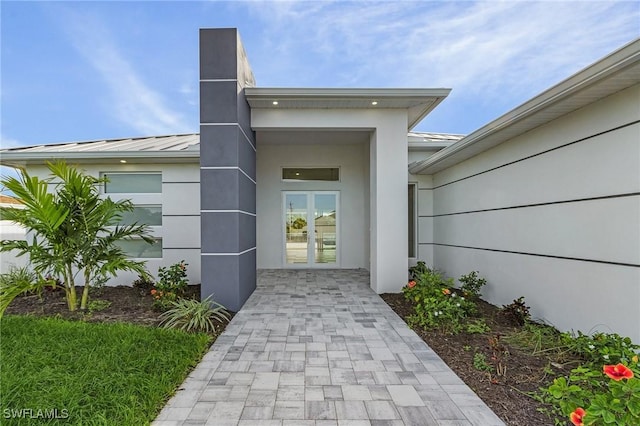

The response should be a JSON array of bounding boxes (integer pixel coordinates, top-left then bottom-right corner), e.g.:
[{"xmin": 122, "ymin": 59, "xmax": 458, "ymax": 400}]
[{"xmin": 251, "ymin": 109, "xmax": 408, "ymax": 293}]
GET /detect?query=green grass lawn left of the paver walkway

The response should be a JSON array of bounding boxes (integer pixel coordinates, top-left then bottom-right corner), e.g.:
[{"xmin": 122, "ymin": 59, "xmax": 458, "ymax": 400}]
[{"xmin": 0, "ymin": 316, "xmax": 210, "ymax": 425}]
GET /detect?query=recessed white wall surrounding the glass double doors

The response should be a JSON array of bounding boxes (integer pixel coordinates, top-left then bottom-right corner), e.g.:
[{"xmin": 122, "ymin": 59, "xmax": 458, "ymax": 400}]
[{"xmin": 256, "ymin": 144, "xmax": 369, "ymax": 269}]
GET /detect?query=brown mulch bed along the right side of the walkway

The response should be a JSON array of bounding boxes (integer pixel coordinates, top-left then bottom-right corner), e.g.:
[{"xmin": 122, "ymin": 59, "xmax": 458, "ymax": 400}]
[{"xmin": 381, "ymin": 293, "xmax": 554, "ymax": 426}]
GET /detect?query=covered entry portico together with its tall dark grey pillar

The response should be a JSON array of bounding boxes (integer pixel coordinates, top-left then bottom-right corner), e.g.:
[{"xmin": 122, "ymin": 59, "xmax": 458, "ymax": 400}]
[{"xmin": 200, "ymin": 29, "xmax": 449, "ymax": 311}]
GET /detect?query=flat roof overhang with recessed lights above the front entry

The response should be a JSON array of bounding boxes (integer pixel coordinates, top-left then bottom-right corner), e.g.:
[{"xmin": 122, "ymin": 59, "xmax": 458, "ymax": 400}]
[{"xmin": 245, "ymin": 87, "xmax": 451, "ymax": 130}]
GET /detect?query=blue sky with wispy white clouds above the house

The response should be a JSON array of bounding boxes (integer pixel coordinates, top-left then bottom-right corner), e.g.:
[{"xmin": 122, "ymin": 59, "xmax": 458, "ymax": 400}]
[{"xmin": 0, "ymin": 1, "xmax": 640, "ymax": 148}]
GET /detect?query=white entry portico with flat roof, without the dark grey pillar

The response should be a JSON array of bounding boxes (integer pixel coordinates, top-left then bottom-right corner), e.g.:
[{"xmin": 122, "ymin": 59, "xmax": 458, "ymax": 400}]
[{"xmin": 245, "ymin": 87, "xmax": 448, "ymax": 293}]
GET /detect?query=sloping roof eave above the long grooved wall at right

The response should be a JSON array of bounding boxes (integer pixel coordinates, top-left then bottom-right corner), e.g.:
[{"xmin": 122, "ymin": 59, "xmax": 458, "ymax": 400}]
[{"xmin": 409, "ymin": 39, "xmax": 640, "ymax": 174}]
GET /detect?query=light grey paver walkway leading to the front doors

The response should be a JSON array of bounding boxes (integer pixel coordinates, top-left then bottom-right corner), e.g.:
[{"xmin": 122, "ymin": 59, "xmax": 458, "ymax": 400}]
[{"xmin": 153, "ymin": 270, "xmax": 504, "ymax": 426}]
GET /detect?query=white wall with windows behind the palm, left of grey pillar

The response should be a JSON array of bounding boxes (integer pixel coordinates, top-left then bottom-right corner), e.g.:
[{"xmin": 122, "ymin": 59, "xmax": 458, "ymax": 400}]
[{"xmin": 15, "ymin": 163, "xmax": 200, "ymax": 285}]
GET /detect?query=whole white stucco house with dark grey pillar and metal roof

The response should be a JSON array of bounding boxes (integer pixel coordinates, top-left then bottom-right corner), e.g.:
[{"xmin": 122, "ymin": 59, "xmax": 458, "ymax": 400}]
[{"xmin": 0, "ymin": 29, "xmax": 640, "ymax": 342}]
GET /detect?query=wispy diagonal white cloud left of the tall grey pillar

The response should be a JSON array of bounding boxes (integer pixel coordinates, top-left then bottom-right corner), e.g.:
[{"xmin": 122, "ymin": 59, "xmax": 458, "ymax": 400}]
[{"xmin": 57, "ymin": 9, "xmax": 191, "ymax": 135}]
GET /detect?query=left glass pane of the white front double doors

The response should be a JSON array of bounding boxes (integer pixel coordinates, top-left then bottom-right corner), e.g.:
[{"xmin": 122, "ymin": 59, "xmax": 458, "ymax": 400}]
[{"xmin": 284, "ymin": 193, "xmax": 309, "ymax": 264}]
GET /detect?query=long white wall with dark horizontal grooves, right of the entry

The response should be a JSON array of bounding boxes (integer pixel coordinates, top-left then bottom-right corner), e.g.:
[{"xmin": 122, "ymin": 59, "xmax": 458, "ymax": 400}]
[{"xmin": 428, "ymin": 85, "xmax": 640, "ymax": 342}]
